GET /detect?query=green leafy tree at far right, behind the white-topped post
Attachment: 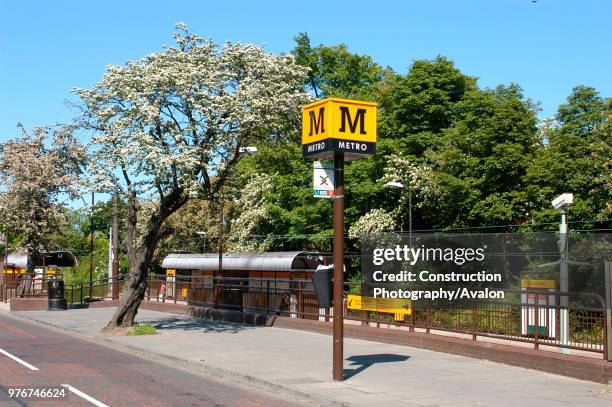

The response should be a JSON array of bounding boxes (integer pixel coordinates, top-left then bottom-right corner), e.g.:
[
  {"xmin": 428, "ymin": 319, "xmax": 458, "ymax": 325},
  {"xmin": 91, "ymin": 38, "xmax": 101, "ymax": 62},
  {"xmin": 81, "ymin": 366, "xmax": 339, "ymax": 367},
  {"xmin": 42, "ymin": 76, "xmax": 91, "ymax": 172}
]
[{"xmin": 525, "ymin": 86, "xmax": 612, "ymax": 226}]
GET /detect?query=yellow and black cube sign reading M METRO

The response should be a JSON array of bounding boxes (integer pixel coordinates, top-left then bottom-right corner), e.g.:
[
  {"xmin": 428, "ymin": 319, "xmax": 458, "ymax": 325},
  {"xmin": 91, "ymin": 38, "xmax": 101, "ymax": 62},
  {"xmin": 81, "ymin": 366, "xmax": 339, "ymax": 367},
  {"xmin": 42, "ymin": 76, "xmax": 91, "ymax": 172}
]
[{"xmin": 302, "ymin": 98, "xmax": 376, "ymax": 160}]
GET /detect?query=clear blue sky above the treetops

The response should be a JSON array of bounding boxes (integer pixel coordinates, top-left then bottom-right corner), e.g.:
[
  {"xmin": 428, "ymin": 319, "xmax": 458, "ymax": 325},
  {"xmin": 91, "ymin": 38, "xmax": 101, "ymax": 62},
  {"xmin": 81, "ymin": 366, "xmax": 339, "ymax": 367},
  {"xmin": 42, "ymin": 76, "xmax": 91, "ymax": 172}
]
[{"xmin": 0, "ymin": 0, "xmax": 612, "ymax": 140}]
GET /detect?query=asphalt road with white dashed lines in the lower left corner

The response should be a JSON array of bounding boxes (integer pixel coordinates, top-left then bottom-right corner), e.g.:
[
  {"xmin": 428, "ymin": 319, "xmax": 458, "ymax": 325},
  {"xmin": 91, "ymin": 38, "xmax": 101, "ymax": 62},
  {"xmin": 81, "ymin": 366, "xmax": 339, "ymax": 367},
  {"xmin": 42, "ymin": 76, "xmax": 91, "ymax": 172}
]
[{"xmin": 0, "ymin": 314, "xmax": 303, "ymax": 407}]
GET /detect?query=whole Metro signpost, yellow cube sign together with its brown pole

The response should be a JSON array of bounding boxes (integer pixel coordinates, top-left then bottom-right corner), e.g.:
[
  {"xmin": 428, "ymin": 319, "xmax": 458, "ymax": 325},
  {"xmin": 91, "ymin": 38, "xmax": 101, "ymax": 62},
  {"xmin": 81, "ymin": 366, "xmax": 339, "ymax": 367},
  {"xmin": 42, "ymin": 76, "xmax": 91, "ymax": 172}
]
[{"xmin": 302, "ymin": 98, "xmax": 376, "ymax": 380}]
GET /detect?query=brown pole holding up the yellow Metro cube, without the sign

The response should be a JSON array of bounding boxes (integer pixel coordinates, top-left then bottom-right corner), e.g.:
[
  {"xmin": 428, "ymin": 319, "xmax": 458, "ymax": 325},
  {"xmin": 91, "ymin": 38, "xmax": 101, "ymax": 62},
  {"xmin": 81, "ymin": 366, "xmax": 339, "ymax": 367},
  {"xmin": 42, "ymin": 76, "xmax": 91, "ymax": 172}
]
[{"xmin": 333, "ymin": 152, "xmax": 344, "ymax": 381}]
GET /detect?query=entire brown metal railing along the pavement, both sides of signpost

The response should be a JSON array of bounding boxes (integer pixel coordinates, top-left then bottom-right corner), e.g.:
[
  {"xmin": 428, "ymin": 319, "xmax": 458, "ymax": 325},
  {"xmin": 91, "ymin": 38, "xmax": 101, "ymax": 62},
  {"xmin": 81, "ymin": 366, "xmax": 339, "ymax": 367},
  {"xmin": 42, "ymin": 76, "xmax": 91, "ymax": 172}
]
[{"xmin": 65, "ymin": 275, "xmax": 607, "ymax": 354}]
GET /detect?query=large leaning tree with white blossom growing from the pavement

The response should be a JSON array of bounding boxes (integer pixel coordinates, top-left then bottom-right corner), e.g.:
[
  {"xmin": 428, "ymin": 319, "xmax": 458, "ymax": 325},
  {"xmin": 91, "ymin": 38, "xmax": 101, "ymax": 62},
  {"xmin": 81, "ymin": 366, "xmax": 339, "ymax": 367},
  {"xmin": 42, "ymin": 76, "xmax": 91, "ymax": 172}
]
[{"xmin": 76, "ymin": 24, "xmax": 308, "ymax": 329}]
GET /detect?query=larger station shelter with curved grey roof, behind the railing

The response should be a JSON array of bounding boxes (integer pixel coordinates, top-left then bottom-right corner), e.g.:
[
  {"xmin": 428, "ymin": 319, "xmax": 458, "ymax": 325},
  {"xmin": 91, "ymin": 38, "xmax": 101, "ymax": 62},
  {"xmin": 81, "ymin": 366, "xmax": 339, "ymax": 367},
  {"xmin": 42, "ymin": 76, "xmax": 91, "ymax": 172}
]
[{"xmin": 162, "ymin": 251, "xmax": 331, "ymax": 319}]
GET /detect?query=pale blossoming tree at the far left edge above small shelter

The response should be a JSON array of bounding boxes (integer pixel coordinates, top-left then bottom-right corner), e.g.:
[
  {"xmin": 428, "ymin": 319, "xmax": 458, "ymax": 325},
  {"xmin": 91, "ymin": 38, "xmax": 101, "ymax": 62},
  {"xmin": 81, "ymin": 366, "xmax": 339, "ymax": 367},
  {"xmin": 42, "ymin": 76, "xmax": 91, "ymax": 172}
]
[{"xmin": 0, "ymin": 125, "xmax": 85, "ymax": 294}]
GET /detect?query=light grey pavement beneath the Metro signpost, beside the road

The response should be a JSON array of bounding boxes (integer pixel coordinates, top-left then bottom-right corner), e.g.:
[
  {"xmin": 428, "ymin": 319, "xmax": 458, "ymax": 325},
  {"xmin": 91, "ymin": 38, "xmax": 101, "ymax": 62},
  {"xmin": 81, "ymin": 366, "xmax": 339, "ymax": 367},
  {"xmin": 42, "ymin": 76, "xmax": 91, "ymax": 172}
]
[{"xmin": 7, "ymin": 308, "xmax": 612, "ymax": 407}]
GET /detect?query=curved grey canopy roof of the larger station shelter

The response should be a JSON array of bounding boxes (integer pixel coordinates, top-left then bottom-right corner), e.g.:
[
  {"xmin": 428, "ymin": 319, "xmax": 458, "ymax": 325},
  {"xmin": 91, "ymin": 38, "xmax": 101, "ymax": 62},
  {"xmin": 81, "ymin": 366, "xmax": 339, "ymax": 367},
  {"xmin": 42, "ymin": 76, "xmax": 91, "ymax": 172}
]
[{"xmin": 162, "ymin": 252, "xmax": 324, "ymax": 271}]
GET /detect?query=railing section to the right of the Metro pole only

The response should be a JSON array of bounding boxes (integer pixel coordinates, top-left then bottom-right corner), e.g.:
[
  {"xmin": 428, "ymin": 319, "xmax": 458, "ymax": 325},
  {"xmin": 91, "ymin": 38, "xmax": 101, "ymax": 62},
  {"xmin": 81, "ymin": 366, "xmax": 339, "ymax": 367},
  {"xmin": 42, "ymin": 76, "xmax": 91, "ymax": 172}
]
[{"xmin": 345, "ymin": 283, "xmax": 607, "ymax": 354}]
